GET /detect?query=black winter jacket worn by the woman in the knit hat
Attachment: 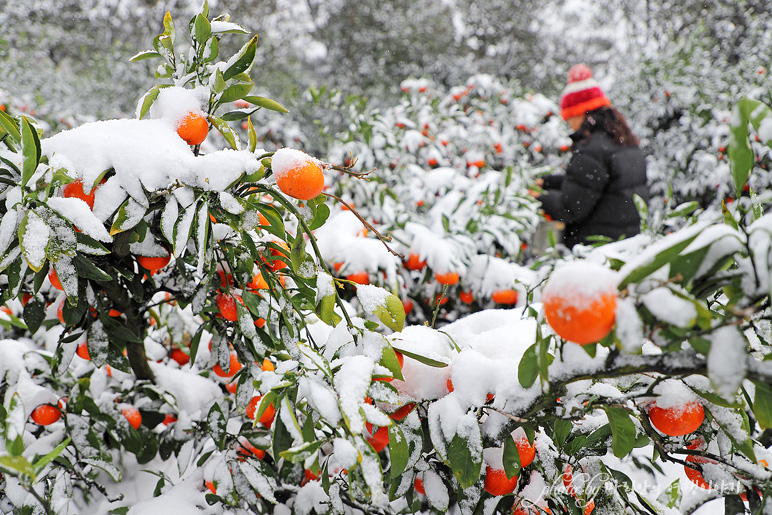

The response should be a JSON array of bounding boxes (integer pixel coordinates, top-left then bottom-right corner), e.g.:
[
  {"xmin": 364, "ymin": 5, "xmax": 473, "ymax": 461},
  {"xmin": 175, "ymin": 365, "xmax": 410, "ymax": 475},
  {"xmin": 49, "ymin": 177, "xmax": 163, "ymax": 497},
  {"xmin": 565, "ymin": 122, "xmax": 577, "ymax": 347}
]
[{"xmin": 538, "ymin": 131, "xmax": 649, "ymax": 248}]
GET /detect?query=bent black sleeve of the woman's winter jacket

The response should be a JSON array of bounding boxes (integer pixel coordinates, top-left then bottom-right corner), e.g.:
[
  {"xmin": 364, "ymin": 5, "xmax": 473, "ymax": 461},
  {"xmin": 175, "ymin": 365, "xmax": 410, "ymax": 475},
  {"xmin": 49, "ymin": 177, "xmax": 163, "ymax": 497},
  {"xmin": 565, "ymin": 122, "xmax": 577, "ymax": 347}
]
[{"xmin": 538, "ymin": 149, "xmax": 609, "ymax": 224}]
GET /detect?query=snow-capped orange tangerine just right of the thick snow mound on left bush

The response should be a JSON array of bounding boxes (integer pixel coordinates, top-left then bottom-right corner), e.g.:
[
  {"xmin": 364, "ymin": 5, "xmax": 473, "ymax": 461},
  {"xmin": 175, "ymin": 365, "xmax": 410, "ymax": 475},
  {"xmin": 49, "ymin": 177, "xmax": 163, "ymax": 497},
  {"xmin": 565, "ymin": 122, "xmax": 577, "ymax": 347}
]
[{"xmin": 271, "ymin": 148, "xmax": 324, "ymax": 200}]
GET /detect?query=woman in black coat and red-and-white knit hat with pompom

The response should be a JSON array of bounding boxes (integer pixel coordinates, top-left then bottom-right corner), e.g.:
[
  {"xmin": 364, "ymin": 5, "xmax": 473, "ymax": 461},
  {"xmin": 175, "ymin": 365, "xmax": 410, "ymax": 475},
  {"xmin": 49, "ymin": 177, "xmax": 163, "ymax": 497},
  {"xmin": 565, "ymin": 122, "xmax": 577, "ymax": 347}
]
[{"xmin": 536, "ymin": 65, "xmax": 649, "ymax": 248}]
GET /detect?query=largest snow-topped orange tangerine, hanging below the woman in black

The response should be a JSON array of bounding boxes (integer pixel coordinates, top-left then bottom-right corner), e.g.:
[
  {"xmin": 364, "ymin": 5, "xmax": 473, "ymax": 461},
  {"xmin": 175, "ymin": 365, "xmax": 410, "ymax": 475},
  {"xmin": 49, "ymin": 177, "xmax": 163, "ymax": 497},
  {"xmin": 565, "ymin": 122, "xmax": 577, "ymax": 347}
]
[{"xmin": 542, "ymin": 261, "xmax": 617, "ymax": 345}]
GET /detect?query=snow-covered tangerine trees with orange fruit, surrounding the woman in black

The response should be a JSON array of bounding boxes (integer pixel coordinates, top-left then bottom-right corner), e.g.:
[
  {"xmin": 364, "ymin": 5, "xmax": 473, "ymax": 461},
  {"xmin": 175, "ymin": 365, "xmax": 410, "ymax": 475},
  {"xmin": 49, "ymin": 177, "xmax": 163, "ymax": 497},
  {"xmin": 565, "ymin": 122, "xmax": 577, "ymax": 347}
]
[{"xmin": 0, "ymin": 2, "xmax": 772, "ymax": 515}]
